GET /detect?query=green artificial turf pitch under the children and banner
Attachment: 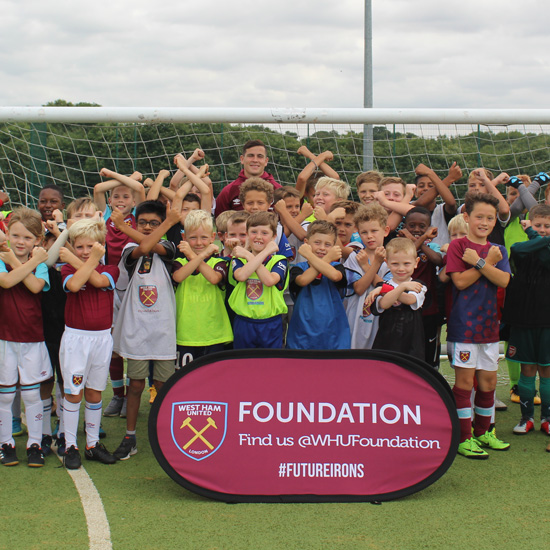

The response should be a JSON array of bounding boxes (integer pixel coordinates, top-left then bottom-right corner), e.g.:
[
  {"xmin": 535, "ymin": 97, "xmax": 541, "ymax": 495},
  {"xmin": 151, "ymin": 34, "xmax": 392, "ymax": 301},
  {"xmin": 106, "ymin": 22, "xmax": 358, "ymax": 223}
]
[{"xmin": 0, "ymin": 363, "xmax": 550, "ymax": 550}]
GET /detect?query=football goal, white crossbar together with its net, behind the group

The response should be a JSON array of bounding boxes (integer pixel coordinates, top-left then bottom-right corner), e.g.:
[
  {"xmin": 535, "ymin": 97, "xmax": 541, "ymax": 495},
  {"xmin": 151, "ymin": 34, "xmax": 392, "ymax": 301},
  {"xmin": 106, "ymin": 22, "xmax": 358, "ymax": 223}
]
[{"xmin": 0, "ymin": 107, "xmax": 550, "ymax": 206}]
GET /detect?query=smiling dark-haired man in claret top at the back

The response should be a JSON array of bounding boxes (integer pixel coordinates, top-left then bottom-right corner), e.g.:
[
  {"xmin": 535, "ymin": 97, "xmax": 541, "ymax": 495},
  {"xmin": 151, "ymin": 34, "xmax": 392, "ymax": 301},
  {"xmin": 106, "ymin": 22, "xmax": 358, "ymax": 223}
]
[{"xmin": 216, "ymin": 139, "xmax": 281, "ymax": 217}]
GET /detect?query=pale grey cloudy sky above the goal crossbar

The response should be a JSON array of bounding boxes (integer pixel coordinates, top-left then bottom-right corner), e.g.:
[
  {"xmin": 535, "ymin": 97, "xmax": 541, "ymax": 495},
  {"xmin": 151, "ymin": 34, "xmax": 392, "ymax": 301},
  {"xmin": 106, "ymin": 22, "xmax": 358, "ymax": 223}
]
[{"xmin": 0, "ymin": 0, "xmax": 550, "ymax": 108}]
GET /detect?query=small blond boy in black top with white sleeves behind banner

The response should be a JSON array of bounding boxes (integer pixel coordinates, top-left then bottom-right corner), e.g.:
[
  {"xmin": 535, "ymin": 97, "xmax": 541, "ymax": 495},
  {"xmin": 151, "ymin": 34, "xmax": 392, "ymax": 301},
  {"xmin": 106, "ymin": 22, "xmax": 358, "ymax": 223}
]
[{"xmin": 374, "ymin": 237, "xmax": 426, "ymax": 360}]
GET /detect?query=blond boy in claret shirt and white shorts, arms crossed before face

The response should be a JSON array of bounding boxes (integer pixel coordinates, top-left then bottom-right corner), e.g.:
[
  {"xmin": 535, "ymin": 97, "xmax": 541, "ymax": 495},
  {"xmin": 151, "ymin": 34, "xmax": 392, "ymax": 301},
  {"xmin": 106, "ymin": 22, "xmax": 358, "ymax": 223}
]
[{"xmin": 59, "ymin": 219, "xmax": 119, "ymax": 470}]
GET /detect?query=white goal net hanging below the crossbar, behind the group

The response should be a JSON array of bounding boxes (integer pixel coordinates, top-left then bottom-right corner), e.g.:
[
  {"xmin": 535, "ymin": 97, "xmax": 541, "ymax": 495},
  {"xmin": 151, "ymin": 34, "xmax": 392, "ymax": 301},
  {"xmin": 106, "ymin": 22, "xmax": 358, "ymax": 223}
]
[{"xmin": 0, "ymin": 107, "xmax": 550, "ymax": 206}]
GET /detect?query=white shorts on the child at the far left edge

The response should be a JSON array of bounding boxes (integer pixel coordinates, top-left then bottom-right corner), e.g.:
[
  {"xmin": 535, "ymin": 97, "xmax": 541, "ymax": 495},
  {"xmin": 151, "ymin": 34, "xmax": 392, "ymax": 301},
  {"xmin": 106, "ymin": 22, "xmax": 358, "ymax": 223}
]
[{"xmin": 0, "ymin": 340, "xmax": 53, "ymax": 386}]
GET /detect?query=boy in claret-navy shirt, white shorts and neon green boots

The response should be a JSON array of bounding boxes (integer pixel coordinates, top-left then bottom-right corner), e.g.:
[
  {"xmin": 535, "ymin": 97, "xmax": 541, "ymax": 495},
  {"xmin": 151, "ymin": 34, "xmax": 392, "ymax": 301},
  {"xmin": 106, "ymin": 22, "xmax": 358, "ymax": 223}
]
[{"xmin": 446, "ymin": 192, "xmax": 510, "ymax": 459}]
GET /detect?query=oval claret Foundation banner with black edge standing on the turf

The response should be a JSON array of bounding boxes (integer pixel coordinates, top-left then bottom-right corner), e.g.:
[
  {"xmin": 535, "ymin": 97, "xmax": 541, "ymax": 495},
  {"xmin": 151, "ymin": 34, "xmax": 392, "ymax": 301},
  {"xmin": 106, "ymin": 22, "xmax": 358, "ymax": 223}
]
[{"xmin": 149, "ymin": 350, "xmax": 459, "ymax": 502}]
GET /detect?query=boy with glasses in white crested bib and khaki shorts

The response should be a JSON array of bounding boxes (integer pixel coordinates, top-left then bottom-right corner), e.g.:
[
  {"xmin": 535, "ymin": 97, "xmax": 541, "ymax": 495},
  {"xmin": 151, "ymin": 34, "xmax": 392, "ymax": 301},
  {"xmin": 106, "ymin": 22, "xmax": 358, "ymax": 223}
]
[{"xmin": 113, "ymin": 201, "xmax": 179, "ymax": 460}]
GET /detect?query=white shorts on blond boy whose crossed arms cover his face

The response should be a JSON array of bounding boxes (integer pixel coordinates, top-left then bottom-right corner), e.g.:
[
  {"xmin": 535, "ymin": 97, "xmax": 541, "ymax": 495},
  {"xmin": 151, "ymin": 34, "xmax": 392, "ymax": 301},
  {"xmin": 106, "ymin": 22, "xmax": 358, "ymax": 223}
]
[{"xmin": 59, "ymin": 327, "xmax": 113, "ymax": 395}]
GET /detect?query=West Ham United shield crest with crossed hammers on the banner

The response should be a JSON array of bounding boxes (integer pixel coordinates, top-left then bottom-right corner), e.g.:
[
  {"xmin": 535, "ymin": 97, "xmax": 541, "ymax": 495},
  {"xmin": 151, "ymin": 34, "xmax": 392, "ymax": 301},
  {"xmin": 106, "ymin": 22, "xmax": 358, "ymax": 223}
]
[{"xmin": 171, "ymin": 401, "xmax": 227, "ymax": 460}]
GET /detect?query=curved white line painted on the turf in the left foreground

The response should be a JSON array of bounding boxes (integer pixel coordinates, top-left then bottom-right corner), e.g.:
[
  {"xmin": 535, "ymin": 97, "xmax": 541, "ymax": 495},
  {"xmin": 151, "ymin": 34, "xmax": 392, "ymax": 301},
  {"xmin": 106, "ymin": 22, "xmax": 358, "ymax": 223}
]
[{"xmin": 54, "ymin": 449, "xmax": 113, "ymax": 550}]
